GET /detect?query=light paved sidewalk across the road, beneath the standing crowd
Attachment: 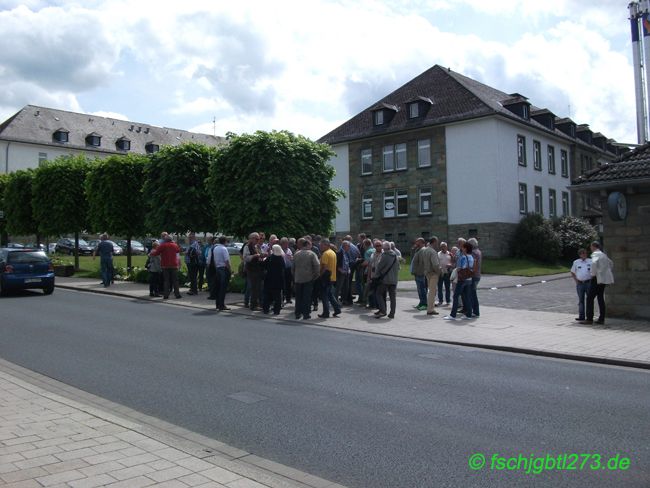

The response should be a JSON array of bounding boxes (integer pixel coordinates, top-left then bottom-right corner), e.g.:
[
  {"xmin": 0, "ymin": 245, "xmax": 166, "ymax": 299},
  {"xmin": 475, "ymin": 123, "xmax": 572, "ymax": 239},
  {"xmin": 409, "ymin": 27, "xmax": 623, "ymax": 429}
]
[{"xmin": 56, "ymin": 275, "xmax": 650, "ymax": 369}]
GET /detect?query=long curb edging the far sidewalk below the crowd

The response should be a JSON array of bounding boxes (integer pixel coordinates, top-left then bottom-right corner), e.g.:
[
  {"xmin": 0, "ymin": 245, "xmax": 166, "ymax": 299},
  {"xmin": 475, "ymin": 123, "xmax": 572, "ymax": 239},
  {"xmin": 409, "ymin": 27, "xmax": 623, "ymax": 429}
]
[{"xmin": 56, "ymin": 277, "xmax": 650, "ymax": 370}]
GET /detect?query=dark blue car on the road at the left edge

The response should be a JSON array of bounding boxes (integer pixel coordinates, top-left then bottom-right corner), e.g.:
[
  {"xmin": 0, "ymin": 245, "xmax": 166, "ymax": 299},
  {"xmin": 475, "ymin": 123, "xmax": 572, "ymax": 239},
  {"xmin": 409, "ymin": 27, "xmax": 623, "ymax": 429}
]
[{"xmin": 0, "ymin": 248, "xmax": 54, "ymax": 295}]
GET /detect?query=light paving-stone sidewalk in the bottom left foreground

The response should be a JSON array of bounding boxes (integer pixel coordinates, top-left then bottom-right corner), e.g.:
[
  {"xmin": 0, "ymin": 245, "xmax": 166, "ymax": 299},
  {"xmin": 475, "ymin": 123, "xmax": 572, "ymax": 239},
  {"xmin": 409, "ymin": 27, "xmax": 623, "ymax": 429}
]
[{"xmin": 0, "ymin": 360, "xmax": 344, "ymax": 488}]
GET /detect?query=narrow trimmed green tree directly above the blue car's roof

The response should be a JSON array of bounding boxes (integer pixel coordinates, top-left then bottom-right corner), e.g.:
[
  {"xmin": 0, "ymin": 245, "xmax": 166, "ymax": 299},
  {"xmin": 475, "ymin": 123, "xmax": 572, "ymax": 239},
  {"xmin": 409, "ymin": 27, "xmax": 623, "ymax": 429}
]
[{"xmin": 4, "ymin": 169, "xmax": 39, "ymax": 240}]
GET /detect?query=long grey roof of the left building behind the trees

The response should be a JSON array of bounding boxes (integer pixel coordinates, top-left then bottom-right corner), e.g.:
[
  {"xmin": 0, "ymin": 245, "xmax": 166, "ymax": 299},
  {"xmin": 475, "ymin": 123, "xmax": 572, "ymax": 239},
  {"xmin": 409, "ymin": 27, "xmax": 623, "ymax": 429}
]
[{"xmin": 0, "ymin": 105, "xmax": 225, "ymax": 154}]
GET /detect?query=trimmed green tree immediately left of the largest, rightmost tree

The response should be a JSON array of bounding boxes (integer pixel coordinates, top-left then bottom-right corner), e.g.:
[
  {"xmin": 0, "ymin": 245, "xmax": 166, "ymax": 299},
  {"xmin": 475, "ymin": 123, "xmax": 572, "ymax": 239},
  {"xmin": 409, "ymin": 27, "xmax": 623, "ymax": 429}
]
[{"xmin": 143, "ymin": 143, "xmax": 216, "ymax": 233}]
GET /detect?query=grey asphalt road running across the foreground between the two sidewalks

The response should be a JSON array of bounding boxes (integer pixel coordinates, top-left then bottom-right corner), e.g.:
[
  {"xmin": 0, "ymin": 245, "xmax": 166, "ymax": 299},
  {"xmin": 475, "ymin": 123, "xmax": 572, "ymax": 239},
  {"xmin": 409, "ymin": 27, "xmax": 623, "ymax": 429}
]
[{"xmin": 0, "ymin": 289, "xmax": 650, "ymax": 488}]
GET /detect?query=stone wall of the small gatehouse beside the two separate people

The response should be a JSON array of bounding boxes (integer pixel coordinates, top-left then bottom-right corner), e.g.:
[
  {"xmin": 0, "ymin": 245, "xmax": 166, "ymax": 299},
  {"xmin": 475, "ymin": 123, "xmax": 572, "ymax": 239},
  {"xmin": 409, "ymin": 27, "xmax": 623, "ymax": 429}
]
[{"xmin": 596, "ymin": 187, "xmax": 650, "ymax": 319}]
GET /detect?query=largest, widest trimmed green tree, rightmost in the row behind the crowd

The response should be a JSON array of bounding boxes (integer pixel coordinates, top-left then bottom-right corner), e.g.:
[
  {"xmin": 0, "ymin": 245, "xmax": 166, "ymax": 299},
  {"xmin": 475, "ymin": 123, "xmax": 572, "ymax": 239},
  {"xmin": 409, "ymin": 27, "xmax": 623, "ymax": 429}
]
[{"xmin": 208, "ymin": 131, "xmax": 343, "ymax": 236}]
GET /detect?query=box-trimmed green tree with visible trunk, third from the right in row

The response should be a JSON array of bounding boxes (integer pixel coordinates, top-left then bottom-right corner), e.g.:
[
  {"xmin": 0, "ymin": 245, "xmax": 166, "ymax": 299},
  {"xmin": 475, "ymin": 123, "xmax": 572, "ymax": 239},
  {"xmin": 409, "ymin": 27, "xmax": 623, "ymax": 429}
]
[{"xmin": 85, "ymin": 154, "xmax": 148, "ymax": 269}]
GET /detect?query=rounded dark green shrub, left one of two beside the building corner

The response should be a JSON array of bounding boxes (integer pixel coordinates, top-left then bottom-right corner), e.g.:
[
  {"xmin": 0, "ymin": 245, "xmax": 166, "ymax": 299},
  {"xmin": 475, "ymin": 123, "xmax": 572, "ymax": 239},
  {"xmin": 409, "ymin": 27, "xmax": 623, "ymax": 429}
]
[{"xmin": 511, "ymin": 213, "xmax": 562, "ymax": 263}]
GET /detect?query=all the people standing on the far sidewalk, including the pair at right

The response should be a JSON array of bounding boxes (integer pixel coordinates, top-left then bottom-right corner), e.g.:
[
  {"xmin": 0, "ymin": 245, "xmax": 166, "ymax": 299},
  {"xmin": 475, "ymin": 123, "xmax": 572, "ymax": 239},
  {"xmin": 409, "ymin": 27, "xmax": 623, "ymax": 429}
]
[{"xmin": 95, "ymin": 232, "xmax": 614, "ymax": 324}]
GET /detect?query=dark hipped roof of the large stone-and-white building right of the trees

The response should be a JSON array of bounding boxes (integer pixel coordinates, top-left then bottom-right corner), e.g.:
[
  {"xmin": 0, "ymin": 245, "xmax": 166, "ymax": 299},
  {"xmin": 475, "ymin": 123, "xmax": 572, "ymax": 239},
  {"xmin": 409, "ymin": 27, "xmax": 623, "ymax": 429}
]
[{"xmin": 319, "ymin": 65, "xmax": 616, "ymax": 156}]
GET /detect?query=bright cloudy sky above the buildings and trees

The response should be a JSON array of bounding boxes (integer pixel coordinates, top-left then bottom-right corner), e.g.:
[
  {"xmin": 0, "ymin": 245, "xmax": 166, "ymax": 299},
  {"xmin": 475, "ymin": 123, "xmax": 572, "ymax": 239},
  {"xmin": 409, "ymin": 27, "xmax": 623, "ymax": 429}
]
[{"xmin": 0, "ymin": 0, "xmax": 636, "ymax": 143}]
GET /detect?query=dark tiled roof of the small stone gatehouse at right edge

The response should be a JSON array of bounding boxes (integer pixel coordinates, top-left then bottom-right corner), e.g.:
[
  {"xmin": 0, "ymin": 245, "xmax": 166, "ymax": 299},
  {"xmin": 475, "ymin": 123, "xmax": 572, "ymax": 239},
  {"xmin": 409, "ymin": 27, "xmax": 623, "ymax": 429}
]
[{"xmin": 571, "ymin": 143, "xmax": 650, "ymax": 190}]
